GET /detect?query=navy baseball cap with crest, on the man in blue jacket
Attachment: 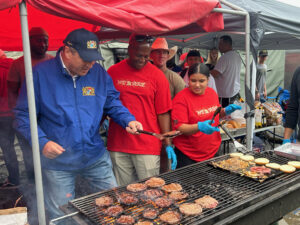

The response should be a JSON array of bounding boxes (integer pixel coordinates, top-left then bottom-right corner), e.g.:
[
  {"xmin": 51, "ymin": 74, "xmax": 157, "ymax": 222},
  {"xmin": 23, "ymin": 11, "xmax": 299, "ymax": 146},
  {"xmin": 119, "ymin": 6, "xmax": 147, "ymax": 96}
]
[{"xmin": 63, "ymin": 28, "xmax": 103, "ymax": 62}]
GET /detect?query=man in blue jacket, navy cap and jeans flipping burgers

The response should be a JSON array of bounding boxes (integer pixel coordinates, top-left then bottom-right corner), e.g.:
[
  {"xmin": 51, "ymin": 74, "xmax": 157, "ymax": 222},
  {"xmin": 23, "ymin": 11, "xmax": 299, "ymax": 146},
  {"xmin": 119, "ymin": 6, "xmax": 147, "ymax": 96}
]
[{"xmin": 15, "ymin": 29, "xmax": 142, "ymax": 219}]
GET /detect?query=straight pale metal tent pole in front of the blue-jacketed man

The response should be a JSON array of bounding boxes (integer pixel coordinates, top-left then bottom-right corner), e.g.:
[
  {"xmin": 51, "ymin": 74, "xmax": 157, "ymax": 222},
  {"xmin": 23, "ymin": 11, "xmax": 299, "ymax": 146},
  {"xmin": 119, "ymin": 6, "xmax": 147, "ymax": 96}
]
[{"xmin": 19, "ymin": 1, "xmax": 46, "ymax": 225}]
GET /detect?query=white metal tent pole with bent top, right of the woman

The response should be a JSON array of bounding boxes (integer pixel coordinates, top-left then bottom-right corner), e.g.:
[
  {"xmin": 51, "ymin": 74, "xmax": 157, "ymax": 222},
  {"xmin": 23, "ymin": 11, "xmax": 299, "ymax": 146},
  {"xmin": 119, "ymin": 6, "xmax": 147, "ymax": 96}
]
[{"xmin": 213, "ymin": 0, "xmax": 256, "ymax": 150}]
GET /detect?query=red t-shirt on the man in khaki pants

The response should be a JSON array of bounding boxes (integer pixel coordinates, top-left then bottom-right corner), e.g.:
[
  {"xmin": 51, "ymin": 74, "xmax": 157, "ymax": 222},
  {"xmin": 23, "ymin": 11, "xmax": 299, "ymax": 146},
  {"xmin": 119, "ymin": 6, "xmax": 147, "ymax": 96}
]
[{"xmin": 107, "ymin": 60, "xmax": 172, "ymax": 155}]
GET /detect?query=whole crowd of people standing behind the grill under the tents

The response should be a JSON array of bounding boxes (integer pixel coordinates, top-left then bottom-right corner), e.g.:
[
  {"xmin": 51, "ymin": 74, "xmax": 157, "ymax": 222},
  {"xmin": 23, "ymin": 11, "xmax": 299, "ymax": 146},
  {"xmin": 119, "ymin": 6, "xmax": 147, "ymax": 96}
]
[{"xmin": 0, "ymin": 27, "xmax": 300, "ymax": 224}]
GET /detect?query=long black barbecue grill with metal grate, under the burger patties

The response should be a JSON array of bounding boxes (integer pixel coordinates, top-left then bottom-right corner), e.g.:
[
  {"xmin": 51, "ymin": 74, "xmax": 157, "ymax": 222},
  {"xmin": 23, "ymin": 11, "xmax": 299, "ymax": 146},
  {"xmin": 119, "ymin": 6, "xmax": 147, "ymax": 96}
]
[{"xmin": 52, "ymin": 152, "xmax": 300, "ymax": 224}]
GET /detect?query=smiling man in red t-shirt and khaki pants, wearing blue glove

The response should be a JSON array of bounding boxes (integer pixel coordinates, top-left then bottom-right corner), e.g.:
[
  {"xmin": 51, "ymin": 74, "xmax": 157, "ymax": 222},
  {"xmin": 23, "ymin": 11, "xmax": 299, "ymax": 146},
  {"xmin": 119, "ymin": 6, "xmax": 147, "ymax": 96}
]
[{"xmin": 107, "ymin": 34, "xmax": 177, "ymax": 185}]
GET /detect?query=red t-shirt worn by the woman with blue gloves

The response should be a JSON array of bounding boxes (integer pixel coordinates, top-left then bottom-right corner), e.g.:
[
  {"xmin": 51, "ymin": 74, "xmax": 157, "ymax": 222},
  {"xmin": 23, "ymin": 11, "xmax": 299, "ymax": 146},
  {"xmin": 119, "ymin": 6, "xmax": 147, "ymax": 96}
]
[{"xmin": 172, "ymin": 87, "xmax": 221, "ymax": 162}]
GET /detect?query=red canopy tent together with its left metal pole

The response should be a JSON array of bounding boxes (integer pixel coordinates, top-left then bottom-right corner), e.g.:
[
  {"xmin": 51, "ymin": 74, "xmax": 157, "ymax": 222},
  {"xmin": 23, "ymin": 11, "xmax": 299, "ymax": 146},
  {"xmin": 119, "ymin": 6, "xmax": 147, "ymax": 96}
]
[{"xmin": 0, "ymin": 0, "xmax": 223, "ymax": 225}]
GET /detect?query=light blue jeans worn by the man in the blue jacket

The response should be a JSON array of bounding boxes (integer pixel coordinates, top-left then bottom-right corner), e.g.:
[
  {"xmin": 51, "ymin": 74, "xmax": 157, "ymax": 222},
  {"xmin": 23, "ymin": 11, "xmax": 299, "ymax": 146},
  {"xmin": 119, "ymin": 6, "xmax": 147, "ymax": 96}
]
[{"xmin": 43, "ymin": 151, "xmax": 117, "ymax": 220}]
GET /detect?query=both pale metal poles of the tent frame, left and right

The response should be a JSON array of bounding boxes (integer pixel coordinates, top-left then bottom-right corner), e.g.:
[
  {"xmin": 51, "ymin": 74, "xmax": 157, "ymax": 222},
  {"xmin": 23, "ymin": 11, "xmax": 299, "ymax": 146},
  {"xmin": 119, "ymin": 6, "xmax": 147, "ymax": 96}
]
[{"xmin": 19, "ymin": 0, "xmax": 256, "ymax": 225}]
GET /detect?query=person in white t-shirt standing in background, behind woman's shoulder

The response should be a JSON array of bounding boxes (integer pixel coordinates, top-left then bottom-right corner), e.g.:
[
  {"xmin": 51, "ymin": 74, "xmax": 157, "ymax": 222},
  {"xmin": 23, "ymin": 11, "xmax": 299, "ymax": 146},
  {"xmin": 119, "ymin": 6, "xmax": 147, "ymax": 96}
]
[{"xmin": 210, "ymin": 35, "xmax": 241, "ymax": 107}]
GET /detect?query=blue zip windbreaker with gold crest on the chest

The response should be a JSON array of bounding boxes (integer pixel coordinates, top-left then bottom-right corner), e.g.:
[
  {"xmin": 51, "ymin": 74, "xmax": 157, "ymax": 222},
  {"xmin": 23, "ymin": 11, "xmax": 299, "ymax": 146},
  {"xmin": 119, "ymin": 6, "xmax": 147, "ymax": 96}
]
[{"xmin": 14, "ymin": 51, "xmax": 135, "ymax": 170}]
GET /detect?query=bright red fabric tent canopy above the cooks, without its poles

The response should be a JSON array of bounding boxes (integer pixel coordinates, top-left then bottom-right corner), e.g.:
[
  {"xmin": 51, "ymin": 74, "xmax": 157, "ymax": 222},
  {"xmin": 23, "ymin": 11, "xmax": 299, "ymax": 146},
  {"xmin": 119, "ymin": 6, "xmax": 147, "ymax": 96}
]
[{"xmin": 0, "ymin": 0, "xmax": 224, "ymax": 51}]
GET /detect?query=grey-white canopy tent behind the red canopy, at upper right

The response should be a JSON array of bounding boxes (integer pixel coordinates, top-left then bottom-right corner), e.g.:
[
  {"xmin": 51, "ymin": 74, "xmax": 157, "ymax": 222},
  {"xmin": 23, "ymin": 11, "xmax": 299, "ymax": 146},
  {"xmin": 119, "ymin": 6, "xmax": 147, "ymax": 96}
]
[{"xmin": 164, "ymin": 0, "xmax": 300, "ymax": 50}]
